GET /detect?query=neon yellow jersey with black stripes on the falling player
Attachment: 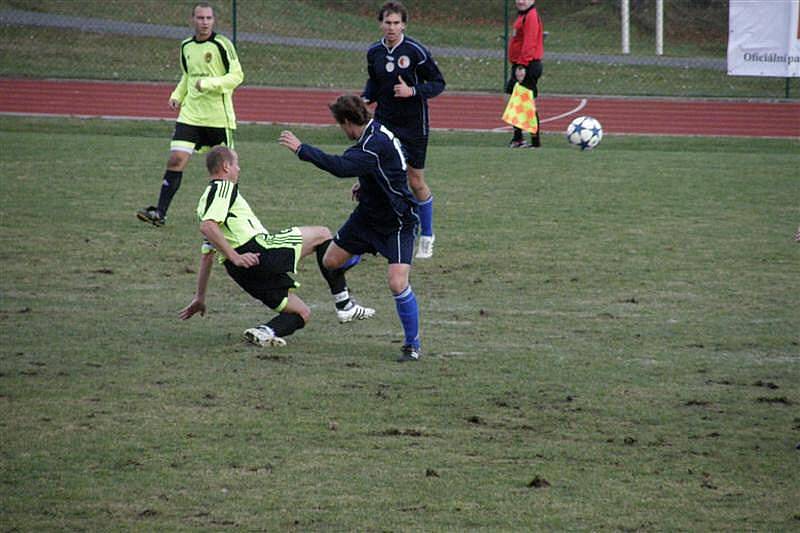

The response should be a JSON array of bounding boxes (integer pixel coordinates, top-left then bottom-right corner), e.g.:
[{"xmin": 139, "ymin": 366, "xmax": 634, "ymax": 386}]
[{"xmin": 197, "ymin": 179, "xmax": 269, "ymax": 262}]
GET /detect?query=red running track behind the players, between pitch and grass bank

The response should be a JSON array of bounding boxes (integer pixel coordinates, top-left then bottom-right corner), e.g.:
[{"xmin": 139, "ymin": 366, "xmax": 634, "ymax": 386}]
[{"xmin": 0, "ymin": 78, "xmax": 800, "ymax": 139}]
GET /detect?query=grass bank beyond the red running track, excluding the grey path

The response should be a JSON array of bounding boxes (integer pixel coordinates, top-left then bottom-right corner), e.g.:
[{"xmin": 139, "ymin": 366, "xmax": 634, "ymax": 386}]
[{"xmin": 0, "ymin": 0, "xmax": 800, "ymax": 98}]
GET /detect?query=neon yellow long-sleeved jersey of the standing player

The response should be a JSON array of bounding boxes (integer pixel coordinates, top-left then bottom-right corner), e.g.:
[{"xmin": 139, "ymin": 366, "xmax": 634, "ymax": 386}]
[{"xmin": 170, "ymin": 33, "xmax": 244, "ymax": 129}]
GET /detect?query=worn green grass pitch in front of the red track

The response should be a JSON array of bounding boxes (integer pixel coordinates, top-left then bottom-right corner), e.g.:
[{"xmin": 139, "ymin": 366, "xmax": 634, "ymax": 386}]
[{"xmin": 0, "ymin": 117, "xmax": 800, "ymax": 531}]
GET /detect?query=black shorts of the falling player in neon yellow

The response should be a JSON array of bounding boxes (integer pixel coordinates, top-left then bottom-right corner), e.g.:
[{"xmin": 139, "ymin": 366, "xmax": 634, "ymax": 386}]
[{"xmin": 223, "ymin": 238, "xmax": 300, "ymax": 312}]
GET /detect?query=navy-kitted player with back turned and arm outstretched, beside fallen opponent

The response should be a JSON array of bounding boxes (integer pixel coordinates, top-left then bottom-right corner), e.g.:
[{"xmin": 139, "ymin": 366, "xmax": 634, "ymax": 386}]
[{"xmin": 279, "ymin": 95, "xmax": 422, "ymax": 362}]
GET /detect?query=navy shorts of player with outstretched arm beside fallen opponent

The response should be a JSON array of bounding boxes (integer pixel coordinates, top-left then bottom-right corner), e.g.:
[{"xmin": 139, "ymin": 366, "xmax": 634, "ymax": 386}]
[{"xmin": 333, "ymin": 211, "xmax": 417, "ymax": 265}]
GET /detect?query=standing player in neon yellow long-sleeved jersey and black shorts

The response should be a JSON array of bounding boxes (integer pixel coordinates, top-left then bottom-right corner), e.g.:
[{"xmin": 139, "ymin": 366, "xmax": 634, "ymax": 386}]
[{"xmin": 136, "ymin": 3, "xmax": 244, "ymax": 226}]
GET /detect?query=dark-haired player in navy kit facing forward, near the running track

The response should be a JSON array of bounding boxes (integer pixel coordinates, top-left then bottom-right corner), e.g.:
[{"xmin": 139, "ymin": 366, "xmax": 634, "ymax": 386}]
[{"xmin": 361, "ymin": 2, "xmax": 445, "ymax": 258}]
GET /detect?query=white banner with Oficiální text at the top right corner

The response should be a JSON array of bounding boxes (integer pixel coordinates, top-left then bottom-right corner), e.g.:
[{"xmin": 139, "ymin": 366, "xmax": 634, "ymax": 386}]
[{"xmin": 728, "ymin": 0, "xmax": 800, "ymax": 78}]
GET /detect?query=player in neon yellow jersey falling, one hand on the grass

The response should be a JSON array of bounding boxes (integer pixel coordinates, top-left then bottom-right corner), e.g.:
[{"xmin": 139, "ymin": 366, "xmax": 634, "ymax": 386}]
[{"xmin": 179, "ymin": 146, "xmax": 375, "ymax": 346}]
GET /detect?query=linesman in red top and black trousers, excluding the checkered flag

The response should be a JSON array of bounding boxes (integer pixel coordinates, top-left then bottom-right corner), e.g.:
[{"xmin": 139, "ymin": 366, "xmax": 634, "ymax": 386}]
[{"xmin": 506, "ymin": 0, "xmax": 544, "ymax": 148}]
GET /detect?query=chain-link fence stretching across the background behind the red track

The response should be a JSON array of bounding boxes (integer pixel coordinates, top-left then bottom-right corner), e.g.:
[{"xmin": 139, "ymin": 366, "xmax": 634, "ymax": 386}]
[{"xmin": 0, "ymin": 0, "xmax": 800, "ymax": 98}]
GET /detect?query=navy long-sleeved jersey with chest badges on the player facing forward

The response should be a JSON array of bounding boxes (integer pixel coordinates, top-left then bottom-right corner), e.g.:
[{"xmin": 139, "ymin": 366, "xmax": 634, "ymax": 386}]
[{"xmin": 362, "ymin": 35, "xmax": 445, "ymax": 139}]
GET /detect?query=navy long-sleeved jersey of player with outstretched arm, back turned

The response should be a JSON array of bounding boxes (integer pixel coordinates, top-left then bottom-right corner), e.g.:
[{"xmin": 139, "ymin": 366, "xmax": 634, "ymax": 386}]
[{"xmin": 297, "ymin": 120, "xmax": 417, "ymax": 232}]
